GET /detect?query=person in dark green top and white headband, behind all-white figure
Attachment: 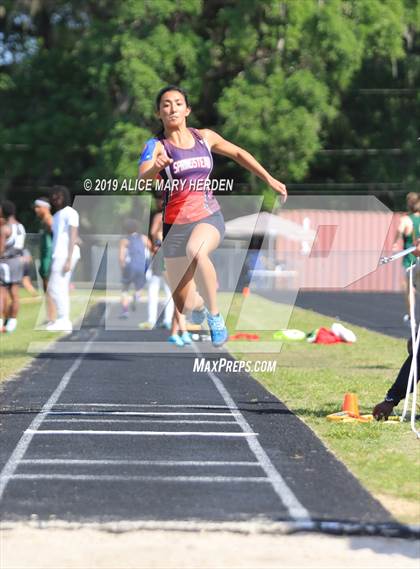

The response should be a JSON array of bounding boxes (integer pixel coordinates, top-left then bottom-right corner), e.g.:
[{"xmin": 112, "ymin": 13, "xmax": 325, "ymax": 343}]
[{"xmin": 34, "ymin": 198, "xmax": 56, "ymax": 324}]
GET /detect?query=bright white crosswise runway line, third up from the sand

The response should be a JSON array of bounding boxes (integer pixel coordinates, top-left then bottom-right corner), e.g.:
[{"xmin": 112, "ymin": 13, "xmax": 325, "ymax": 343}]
[{"xmin": 26, "ymin": 429, "xmax": 258, "ymax": 438}]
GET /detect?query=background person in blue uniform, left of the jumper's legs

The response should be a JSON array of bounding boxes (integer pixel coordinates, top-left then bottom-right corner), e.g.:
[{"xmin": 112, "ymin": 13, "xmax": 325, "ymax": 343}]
[{"xmin": 119, "ymin": 219, "xmax": 149, "ymax": 318}]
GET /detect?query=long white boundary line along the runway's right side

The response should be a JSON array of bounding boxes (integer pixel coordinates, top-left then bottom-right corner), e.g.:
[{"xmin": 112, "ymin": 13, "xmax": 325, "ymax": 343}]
[{"xmin": 193, "ymin": 342, "xmax": 312, "ymax": 523}]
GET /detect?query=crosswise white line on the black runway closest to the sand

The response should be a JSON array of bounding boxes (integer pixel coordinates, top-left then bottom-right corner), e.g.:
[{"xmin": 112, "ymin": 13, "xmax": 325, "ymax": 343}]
[{"xmin": 12, "ymin": 474, "xmax": 270, "ymax": 484}]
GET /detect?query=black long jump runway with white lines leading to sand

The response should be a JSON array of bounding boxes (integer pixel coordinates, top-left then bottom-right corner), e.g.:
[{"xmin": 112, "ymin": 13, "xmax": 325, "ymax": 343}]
[{"xmin": 0, "ymin": 302, "xmax": 392, "ymax": 524}]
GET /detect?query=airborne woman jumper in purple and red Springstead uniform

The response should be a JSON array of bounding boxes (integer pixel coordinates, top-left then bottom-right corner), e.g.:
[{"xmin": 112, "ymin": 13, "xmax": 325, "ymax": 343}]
[{"xmin": 139, "ymin": 85, "xmax": 287, "ymax": 347}]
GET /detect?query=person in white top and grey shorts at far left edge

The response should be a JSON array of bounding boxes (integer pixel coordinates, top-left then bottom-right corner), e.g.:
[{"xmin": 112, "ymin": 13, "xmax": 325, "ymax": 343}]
[{"xmin": 0, "ymin": 201, "xmax": 26, "ymax": 332}]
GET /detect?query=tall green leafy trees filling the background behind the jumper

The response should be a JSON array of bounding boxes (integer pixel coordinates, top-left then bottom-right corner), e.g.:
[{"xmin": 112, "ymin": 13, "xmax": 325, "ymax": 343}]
[{"xmin": 0, "ymin": 0, "xmax": 420, "ymax": 226}]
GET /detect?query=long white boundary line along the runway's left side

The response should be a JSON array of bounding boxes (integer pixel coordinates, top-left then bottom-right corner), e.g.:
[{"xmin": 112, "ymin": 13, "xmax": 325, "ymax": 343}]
[{"xmin": 0, "ymin": 329, "xmax": 99, "ymax": 500}]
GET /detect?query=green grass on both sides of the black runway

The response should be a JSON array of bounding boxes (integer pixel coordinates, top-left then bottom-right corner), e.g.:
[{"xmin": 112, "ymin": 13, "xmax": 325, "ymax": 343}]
[{"xmin": 0, "ymin": 292, "xmax": 420, "ymax": 523}]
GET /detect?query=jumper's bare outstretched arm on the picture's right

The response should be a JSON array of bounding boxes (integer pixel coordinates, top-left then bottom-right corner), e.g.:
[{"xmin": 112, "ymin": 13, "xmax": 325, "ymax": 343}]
[{"xmin": 200, "ymin": 129, "xmax": 287, "ymax": 198}]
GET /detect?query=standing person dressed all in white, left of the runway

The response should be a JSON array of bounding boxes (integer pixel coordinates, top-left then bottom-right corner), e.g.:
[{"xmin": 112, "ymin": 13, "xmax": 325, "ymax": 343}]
[{"xmin": 47, "ymin": 186, "xmax": 80, "ymax": 332}]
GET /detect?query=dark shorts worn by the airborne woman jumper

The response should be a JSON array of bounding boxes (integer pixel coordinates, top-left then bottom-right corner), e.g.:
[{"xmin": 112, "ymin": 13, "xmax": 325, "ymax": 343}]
[{"xmin": 162, "ymin": 210, "xmax": 225, "ymax": 257}]
